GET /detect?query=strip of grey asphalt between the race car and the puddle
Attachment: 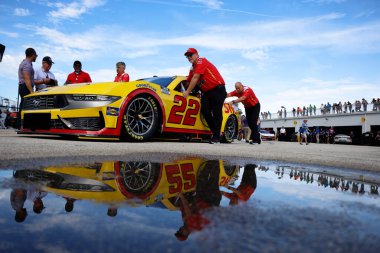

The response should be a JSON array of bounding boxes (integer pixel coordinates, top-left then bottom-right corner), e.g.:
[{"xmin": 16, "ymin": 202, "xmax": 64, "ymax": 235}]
[{"xmin": 0, "ymin": 129, "xmax": 380, "ymax": 172}]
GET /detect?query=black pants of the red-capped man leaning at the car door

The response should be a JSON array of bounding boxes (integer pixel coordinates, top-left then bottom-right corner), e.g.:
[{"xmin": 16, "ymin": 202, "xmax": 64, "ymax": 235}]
[{"xmin": 201, "ymin": 85, "xmax": 227, "ymax": 140}]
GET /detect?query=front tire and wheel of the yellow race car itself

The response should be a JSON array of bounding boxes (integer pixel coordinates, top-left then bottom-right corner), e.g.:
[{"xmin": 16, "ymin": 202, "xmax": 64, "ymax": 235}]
[{"xmin": 123, "ymin": 96, "xmax": 158, "ymax": 141}]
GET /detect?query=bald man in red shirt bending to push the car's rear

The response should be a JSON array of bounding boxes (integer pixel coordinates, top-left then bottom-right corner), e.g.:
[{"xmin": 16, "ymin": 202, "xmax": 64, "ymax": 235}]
[{"xmin": 227, "ymin": 82, "xmax": 261, "ymax": 144}]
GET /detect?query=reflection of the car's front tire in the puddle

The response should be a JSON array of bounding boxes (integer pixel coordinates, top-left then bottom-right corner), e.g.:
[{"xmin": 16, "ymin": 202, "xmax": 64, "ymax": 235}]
[{"xmin": 119, "ymin": 161, "xmax": 160, "ymax": 196}]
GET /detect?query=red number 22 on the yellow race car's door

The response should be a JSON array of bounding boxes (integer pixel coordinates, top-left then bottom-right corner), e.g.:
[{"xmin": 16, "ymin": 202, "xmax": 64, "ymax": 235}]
[{"xmin": 168, "ymin": 95, "xmax": 200, "ymax": 126}]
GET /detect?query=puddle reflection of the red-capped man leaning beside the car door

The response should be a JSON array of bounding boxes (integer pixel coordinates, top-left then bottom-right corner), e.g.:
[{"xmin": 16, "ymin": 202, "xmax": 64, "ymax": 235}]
[{"xmin": 175, "ymin": 160, "xmax": 222, "ymax": 241}]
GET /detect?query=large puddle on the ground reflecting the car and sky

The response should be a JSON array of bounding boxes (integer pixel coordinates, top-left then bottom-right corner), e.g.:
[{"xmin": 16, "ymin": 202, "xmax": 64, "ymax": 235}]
[{"xmin": 0, "ymin": 158, "xmax": 380, "ymax": 252}]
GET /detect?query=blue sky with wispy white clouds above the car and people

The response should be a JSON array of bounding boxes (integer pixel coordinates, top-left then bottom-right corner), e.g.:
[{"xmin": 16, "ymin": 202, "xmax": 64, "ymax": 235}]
[{"xmin": 0, "ymin": 0, "xmax": 380, "ymax": 112}]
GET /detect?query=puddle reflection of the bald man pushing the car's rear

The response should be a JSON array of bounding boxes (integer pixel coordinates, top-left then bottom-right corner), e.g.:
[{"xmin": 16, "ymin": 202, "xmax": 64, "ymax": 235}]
[{"xmin": 221, "ymin": 164, "xmax": 257, "ymax": 205}]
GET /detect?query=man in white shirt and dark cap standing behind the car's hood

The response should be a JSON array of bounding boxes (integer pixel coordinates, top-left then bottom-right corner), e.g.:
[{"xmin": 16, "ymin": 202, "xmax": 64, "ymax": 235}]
[{"xmin": 34, "ymin": 56, "xmax": 58, "ymax": 91}]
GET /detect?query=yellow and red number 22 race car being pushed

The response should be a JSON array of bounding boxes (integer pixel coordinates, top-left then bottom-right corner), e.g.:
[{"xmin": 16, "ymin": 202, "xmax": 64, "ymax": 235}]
[{"xmin": 20, "ymin": 76, "xmax": 238, "ymax": 143}]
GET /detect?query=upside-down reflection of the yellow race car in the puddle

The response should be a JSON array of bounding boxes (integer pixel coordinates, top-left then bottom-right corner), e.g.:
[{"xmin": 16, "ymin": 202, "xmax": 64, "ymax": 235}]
[{"xmin": 15, "ymin": 158, "xmax": 239, "ymax": 209}]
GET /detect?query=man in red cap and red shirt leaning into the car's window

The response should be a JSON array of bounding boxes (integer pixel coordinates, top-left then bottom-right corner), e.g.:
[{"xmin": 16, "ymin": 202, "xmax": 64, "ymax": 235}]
[{"xmin": 183, "ymin": 48, "xmax": 227, "ymax": 144}]
